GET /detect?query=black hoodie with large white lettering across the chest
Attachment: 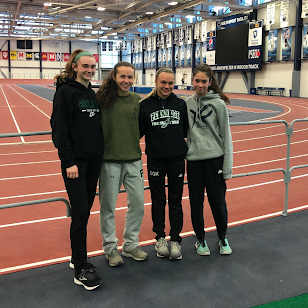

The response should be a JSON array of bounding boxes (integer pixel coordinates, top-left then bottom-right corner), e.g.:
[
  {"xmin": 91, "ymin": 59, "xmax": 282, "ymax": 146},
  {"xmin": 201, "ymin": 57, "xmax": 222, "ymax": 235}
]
[{"xmin": 139, "ymin": 93, "xmax": 188, "ymax": 158}]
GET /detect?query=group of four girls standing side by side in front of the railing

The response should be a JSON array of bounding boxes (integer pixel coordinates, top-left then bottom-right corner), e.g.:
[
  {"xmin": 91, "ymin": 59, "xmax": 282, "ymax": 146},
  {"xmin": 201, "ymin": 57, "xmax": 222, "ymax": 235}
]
[{"xmin": 51, "ymin": 49, "xmax": 232, "ymax": 290}]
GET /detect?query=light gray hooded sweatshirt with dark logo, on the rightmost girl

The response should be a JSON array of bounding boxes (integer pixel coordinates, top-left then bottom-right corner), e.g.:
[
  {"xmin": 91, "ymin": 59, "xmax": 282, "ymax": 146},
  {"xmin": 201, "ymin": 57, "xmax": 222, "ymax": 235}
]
[{"xmin": 186, "ymin": 90, "xmax": 233, "ymax": 179}]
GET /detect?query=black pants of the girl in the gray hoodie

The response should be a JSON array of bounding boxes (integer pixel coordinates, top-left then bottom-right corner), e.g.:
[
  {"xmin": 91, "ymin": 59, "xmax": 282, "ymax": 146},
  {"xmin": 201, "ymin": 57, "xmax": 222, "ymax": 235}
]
[{"xmin": 187, "ymin": 157, "xmax": 228, "ymax": 239}]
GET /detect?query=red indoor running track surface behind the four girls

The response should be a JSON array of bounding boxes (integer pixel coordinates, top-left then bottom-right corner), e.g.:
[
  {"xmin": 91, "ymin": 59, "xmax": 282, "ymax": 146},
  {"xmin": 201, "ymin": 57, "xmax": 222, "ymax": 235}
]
[{"xmin": 0, "ymin": 80, "xmax": 308, "ymax": 274}]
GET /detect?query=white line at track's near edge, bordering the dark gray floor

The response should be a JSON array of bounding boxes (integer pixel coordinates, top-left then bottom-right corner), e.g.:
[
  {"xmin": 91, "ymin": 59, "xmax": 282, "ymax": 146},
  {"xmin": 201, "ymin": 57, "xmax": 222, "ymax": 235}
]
[{"xmin": 0, "ymin": 205, "xmax": 308, "ymax": 274}]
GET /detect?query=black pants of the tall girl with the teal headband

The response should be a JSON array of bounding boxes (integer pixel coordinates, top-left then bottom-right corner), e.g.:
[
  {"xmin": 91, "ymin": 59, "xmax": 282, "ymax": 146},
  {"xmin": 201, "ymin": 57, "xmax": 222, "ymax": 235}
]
[{"xmin": 62, "ymin": 158, "xmax": 102, "ymax": 273}]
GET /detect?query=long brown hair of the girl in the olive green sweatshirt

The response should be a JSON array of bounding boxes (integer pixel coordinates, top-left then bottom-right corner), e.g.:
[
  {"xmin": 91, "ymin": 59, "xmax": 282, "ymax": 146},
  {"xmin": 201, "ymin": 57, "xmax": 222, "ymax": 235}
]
[{"xmin": 96, "ymin": 61, "xmax": 135, "ymax": 107}]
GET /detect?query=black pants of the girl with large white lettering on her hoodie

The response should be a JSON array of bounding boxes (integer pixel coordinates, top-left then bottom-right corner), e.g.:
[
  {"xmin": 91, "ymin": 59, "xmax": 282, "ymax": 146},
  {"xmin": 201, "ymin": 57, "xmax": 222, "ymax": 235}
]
[{"xmin": 147, "ymin": 156, "xmax": 185, "ymax": 243}]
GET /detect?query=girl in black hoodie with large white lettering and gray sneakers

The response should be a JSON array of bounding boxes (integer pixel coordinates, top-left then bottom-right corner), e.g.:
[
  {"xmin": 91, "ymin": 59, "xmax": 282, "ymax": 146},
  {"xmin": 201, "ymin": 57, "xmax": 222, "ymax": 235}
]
[{"xmin": 139, "ymin": 68, "xmax": 188, "ymax": 260}]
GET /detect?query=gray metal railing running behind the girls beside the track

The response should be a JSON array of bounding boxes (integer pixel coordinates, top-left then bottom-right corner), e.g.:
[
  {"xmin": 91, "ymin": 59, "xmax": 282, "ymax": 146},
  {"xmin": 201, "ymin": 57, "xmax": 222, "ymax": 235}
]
[{"xmin": 0, "ymin": 119, "xmax": 308, "ymax": 217}]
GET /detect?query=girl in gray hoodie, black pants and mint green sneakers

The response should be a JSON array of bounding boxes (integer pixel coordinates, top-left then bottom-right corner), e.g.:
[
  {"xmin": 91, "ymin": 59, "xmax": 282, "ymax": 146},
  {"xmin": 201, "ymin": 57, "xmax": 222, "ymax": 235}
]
[{"xmin": 186, "ymin": 64, "xmax": 233, "ymax": 255}]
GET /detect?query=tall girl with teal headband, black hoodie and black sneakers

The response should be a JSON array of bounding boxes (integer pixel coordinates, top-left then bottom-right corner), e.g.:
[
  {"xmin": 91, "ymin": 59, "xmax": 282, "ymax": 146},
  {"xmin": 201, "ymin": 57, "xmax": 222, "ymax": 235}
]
[{"xmin": 50, "ymin": 49, "xmax": 104, "ymax": 290}]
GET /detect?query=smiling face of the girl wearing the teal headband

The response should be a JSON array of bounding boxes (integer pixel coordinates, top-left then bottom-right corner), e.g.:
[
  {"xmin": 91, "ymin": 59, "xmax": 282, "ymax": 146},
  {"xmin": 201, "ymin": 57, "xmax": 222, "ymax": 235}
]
[{"xmin": 72, "ymin": 56, "xmax": 96, "ymax": 87}]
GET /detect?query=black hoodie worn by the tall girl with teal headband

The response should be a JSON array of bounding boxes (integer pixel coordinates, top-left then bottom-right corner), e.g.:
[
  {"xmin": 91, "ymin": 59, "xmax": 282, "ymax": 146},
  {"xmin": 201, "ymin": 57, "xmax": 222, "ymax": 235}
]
[{"xmin": 50, "ymin": 78, "xmax": 104, "ymax": 168}]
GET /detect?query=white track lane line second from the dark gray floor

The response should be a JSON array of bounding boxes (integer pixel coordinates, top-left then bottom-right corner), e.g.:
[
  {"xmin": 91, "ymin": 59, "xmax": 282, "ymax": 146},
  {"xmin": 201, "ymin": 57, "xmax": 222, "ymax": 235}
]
[{"xmin": 0, "ymin": 174, "xmax": 308, "ymax": 228}]
